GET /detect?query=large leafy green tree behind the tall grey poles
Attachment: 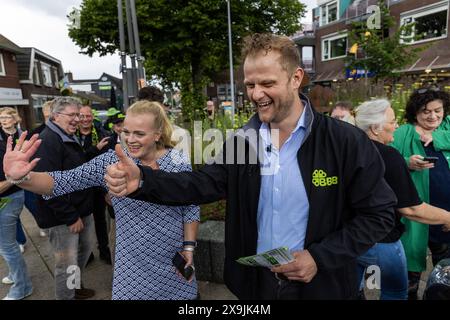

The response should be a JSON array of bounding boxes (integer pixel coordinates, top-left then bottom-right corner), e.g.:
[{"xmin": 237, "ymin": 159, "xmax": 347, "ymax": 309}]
[{"xmin": 69, "ymin": 0, "xmax": 305, "ymax": 118}]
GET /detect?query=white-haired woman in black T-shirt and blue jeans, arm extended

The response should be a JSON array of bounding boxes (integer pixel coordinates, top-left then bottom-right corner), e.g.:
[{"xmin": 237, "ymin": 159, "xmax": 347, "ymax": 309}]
[{"xmin": 355, "ymin": 99, "xmax": 450, "ymax": 300}]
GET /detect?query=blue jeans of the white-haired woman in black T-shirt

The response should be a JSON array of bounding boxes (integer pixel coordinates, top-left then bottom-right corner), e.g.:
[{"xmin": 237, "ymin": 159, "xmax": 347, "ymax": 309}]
[{"xmin": 357, "ymin": 240, "xmax": 408, "ymax": 300}]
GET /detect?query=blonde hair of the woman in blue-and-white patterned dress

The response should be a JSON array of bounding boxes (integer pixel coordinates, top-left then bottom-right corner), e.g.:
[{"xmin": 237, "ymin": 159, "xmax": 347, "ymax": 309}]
[{"xmin": 126, "ymin": 100, "xmax": 175, "ymax": 149}]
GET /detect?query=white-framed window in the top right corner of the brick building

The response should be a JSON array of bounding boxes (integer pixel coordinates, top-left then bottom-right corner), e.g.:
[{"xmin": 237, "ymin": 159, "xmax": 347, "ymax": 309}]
[{"xmin": 401, "ymin": 1, "xmax": 448, "ymax": 44}]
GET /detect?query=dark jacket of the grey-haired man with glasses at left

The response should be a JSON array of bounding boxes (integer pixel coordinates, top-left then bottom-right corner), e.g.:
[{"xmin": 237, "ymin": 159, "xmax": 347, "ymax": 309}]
[{"xmin": 35, "ymin": 121, "xmax": 93, "ymax": 228}]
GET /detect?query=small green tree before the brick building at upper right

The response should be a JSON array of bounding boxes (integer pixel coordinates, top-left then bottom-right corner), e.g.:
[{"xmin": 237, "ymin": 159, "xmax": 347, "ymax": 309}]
[{"xmin": 346, "ymin": 1, "xmax": 427, "ymax": 78}]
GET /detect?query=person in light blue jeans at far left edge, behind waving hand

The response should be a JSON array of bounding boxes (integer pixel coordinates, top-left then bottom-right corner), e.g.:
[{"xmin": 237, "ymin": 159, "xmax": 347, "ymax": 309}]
[{"xmin": 0, "ymin": 107, "xmax": 33, "ymax": 300}]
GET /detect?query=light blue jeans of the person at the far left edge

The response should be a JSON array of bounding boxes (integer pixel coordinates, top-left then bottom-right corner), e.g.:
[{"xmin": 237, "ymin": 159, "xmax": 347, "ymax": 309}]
[{"xmin": 0, "ymin": 191, "xmax": 33, "ymax": 299}]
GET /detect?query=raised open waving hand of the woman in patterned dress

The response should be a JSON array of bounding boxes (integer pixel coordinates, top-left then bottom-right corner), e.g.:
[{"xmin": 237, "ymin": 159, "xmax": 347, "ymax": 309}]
[{"xmin": 3, "ymin": 132, "xmax": 42, "ymax": 180}]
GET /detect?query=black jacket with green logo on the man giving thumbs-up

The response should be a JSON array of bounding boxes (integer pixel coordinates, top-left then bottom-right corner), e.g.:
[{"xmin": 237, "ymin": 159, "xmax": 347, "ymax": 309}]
[{"xmin": 131, "ymin": 96, "xmax": 396, "ymax": 299}]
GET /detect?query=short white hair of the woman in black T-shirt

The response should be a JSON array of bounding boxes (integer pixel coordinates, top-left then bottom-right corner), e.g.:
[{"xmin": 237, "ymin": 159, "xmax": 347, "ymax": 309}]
[{"xmin": 355, "ymin": 99, "xmax": 391, "ymax": 132}]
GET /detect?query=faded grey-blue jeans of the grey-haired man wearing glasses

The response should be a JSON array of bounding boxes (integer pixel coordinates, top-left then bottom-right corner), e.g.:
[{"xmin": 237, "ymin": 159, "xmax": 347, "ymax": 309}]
[{"xmin": 48, "ymin": 214, "xmax": 95, "ymax": 300}]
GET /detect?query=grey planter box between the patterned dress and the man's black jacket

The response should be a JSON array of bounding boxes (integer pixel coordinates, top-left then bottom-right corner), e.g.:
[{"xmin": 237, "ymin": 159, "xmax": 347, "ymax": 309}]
[{"xmin": 194, "ymin": 221, "xmax": 225, "ymax": 283}]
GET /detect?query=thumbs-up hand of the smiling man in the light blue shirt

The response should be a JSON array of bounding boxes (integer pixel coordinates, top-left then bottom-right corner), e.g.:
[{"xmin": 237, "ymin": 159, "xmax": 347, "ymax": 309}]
[{"xmin": 105, "ymin": 144, "xmax": 141, "ymax": 197}]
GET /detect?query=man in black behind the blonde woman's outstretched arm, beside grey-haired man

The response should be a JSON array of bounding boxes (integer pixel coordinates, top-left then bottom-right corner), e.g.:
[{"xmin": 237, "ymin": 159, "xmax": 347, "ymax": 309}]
[{"xmin": 77, "ymin": 106, "xmax": 112, "ymax": 264}]
